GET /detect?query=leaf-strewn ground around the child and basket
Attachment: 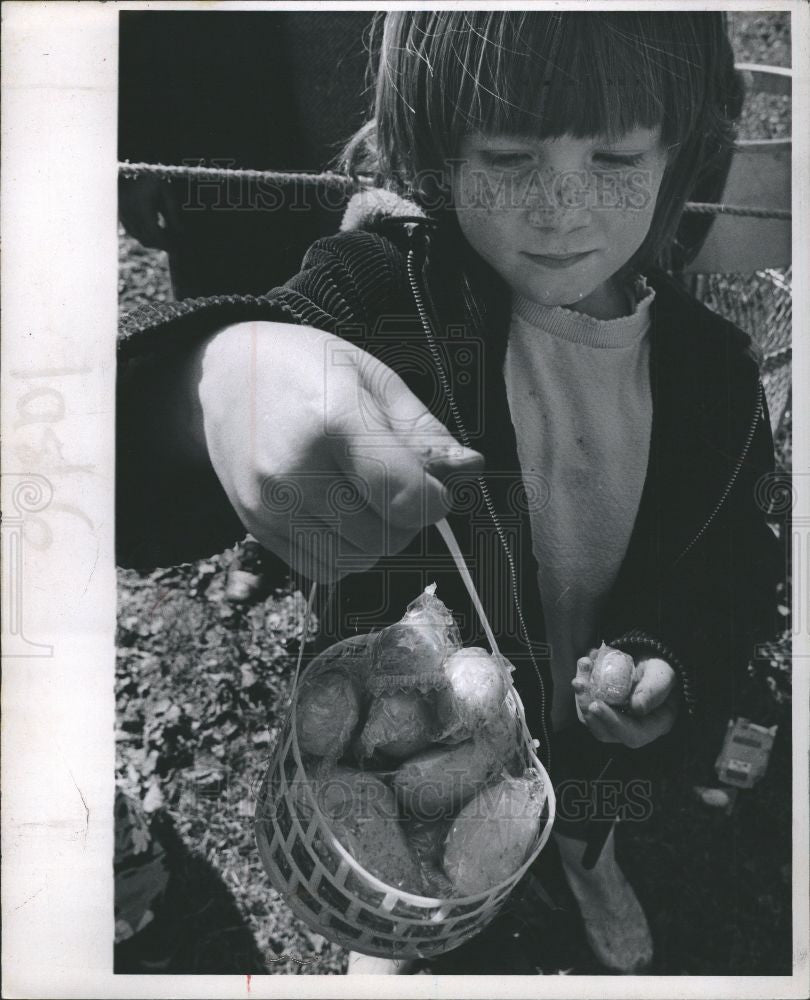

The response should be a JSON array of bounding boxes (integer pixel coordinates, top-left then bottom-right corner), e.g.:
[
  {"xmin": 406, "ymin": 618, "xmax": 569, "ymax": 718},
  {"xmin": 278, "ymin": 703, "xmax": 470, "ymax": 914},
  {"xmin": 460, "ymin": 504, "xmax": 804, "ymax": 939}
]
[{"xmin": 116, "ymin": 14, "xmax": 792, "ymax": 975}]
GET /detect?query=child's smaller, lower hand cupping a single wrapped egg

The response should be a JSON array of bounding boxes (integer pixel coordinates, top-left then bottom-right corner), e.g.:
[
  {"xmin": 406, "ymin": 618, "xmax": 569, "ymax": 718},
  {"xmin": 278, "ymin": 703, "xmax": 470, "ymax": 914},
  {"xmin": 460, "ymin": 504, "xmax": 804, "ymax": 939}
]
[{"xmin": 571, "ymin": 649, "xmax": 680, "ymax": 749}]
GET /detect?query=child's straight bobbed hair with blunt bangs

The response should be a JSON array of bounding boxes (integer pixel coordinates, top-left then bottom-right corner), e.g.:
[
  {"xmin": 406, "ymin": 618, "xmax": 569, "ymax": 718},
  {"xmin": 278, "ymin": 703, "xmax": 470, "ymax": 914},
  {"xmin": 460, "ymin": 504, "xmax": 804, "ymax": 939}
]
[{"xmin": 343, "ymin": 10, "xmax": 743, "ymax": 267}]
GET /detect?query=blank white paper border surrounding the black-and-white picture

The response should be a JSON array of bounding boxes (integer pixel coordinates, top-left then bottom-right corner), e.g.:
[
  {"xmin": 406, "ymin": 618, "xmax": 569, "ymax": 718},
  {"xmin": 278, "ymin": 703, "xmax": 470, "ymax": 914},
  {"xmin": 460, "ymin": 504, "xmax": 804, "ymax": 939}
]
[{"xmin": 0, "ymin": 0, "xmax": 810, "ymax": 998}]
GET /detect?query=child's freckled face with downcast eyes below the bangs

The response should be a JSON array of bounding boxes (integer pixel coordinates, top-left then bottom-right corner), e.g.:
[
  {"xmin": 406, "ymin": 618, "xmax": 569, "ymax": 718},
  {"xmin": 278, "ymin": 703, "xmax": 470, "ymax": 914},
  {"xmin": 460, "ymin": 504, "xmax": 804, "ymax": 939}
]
[{"xmin": 452, "ymin": 128, "xmax": 667, "ymax": 319}]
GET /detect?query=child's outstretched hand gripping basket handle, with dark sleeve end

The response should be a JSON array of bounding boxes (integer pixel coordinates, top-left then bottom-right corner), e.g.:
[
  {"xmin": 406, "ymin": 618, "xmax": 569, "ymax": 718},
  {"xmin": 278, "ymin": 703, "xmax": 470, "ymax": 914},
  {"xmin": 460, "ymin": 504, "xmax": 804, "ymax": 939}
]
[{"xmin": 118, "ymin": 312, "xmax": 480, "ymax": 582}]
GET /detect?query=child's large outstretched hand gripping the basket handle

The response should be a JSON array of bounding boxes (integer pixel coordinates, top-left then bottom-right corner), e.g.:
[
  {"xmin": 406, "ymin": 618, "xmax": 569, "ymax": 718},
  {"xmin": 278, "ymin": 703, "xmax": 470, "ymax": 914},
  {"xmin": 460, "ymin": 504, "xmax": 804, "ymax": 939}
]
[{"xmin": 185, "ymin": 322, "xmax": 482, "ymax": 583}]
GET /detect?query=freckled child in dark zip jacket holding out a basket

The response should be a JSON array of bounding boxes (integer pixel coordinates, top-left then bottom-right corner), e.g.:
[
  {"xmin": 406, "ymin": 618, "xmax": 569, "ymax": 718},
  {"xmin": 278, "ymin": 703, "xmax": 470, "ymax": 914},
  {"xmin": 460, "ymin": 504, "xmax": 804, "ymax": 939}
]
[{"xmin": 118, "ymin": 10, "xmax": 780, "ymax": 972}]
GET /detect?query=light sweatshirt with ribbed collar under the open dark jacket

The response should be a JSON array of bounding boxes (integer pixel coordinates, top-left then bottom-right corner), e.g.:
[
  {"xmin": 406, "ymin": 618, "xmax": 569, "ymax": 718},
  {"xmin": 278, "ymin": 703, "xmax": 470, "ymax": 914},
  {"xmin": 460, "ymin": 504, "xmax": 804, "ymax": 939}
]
[{"xmin": 504, "ymin": 277, "xmax": 655, "ymax": 729}]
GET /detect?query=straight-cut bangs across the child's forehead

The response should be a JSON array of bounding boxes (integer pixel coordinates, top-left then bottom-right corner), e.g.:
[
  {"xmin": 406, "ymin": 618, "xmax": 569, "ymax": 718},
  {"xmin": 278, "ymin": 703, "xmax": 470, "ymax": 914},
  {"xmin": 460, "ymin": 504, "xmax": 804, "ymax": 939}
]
[{"xmin": 437, "ymin": 12, "xmax": 702, "ymax": 153}]
